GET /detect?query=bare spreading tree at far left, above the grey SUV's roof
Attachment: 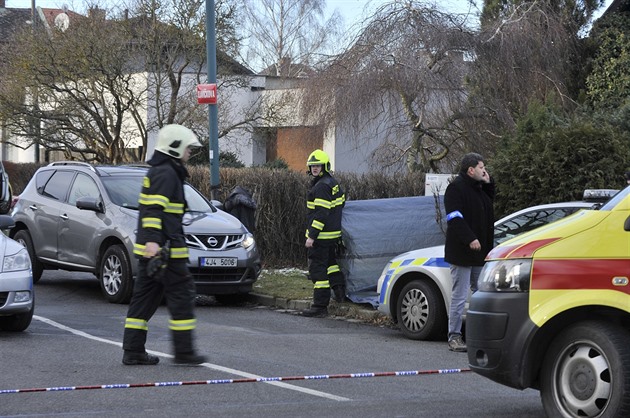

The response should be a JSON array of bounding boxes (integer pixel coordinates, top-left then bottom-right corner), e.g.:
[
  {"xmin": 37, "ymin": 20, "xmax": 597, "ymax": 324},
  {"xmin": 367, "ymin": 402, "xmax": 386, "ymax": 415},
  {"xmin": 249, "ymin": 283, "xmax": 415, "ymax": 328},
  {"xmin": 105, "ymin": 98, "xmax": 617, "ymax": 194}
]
[{"xmin": 0, "ymin": 13, "xmax": 146, "ymax": 163}]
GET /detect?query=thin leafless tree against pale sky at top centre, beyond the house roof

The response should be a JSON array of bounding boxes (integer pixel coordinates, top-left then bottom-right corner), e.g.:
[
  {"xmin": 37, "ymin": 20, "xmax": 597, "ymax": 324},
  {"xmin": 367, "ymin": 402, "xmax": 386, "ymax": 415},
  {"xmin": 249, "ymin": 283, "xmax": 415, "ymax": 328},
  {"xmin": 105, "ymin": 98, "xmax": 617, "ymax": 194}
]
[{"xmin": 244, "ymin": 0, "xmax": 341, "ymax": 77}]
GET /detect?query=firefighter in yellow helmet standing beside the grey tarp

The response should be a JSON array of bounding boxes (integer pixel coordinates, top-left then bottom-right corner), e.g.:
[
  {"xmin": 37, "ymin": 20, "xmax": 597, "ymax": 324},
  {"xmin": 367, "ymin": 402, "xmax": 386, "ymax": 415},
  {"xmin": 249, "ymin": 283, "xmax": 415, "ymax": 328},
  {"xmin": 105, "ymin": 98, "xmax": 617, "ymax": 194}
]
[{"xmin": 302, "ymin": 149, "xmax": 346, "ymax": 317}]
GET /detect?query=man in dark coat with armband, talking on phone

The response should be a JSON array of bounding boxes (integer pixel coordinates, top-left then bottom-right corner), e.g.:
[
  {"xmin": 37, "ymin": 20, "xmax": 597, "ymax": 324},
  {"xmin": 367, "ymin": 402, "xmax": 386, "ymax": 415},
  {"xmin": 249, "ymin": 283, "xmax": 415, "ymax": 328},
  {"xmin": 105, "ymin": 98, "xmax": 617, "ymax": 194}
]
[{"xmin": 444, "ymin": 153, "xmax": 494, "ymax": 352}]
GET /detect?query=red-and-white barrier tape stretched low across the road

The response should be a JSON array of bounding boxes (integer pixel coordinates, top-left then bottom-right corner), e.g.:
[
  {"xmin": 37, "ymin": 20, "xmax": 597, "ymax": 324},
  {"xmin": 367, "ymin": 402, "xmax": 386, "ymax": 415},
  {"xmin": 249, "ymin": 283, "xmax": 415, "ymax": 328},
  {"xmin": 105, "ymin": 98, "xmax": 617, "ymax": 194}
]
[{"xmin": 0, "ymin": 369, "xmax": 471, "ymax": 394}]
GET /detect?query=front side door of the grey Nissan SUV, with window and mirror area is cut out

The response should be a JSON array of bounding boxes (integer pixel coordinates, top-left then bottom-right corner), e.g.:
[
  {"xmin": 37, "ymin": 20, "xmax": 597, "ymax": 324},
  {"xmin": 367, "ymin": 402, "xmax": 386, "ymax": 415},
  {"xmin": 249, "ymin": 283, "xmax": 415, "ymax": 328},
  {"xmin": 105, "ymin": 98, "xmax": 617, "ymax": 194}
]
[{"xmin": 58, "ymin": 172, "xmax": 103, "ymax": 268}]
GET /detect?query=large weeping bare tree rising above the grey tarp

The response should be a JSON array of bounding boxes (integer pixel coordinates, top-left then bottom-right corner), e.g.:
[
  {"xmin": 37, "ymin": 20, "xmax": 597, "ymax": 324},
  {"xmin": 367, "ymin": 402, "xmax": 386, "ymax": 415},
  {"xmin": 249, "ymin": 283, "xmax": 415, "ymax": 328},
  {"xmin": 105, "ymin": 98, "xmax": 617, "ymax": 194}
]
[{"xmin": 303, "ymin": 0, "xmax": 474, "ymax": 172}]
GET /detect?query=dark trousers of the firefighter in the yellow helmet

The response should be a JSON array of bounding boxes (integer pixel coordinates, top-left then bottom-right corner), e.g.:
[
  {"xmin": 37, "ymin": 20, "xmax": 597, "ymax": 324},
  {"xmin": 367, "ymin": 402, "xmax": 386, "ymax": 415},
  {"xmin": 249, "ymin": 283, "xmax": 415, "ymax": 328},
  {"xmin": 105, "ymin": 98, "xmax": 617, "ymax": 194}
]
[{"xmin": 308, "ymin": 240, "xmax": 345, "ymax": 308}]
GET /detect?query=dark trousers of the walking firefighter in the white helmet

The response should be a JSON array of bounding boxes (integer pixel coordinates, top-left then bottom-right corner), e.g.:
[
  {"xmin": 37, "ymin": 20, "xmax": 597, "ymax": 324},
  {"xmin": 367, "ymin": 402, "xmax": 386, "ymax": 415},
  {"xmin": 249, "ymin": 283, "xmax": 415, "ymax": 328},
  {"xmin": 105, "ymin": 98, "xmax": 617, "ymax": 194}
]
[{"xmin": 123, "ymin": 259, "xmax": 196, "ymax": 355}]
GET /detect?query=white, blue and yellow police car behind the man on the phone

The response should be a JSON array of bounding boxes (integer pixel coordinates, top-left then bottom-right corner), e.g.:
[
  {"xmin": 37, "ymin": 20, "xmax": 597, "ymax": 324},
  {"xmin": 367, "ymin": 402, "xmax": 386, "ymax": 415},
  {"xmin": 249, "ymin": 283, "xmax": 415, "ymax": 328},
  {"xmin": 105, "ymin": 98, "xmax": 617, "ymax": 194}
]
[{"xmin": 377, "ymin": 190, "xmax": 617, "ymax": 340}]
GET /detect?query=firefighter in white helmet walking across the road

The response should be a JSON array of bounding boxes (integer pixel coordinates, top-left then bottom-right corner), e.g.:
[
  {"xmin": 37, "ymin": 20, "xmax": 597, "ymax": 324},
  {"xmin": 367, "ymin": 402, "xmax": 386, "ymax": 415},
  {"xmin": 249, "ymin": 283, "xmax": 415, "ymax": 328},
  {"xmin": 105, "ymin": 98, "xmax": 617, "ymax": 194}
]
[{"xmin": 123, "ymin": 125, "xmax": 206, "ymax": 365}]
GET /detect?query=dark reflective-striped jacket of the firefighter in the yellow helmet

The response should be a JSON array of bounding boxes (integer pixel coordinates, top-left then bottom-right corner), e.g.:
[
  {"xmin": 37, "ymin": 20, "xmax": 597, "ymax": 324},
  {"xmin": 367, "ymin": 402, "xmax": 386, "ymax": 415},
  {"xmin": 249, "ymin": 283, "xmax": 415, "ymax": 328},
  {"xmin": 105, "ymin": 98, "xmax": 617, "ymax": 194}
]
[{"xmin": 306, "ymin": 172, "xmax": 346, "ymax": 240}]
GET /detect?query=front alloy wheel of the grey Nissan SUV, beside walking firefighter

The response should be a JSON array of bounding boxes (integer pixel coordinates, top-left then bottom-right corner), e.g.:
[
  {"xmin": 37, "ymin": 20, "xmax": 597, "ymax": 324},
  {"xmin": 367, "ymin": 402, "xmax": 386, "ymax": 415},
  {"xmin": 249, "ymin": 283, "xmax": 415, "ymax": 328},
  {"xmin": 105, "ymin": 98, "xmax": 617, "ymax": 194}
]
[{"xmin": 98, "ymin": 245, "xmax": 133, "ymax": 303}]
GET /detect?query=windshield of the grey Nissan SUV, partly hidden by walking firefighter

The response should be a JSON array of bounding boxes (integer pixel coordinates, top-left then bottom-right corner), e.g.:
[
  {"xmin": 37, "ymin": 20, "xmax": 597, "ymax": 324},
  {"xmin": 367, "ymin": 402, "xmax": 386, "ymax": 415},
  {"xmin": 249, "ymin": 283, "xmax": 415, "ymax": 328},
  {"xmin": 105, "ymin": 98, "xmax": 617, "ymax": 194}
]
[{"xmin": 102, "ymin": 176, "xmax": 212, "ymax": 212}]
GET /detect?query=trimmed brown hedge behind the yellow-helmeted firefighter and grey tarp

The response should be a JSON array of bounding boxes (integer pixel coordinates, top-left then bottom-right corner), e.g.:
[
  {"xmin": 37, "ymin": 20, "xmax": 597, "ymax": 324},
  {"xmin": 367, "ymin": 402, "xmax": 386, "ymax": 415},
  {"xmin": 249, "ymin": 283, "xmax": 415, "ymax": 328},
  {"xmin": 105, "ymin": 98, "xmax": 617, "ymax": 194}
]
[{"xmin": 188, "ymin": 166, "xmax": 424, "ymax": 267}]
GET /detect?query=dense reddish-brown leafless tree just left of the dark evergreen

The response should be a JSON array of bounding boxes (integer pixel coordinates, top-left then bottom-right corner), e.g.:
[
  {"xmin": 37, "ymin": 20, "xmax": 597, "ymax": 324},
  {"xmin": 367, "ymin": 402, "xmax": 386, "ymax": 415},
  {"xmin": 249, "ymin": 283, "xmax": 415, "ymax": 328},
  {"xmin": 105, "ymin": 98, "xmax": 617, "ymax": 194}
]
[{"xmin": 469, "ymin": 1, "xmax": 584, "ymax": 137}]
